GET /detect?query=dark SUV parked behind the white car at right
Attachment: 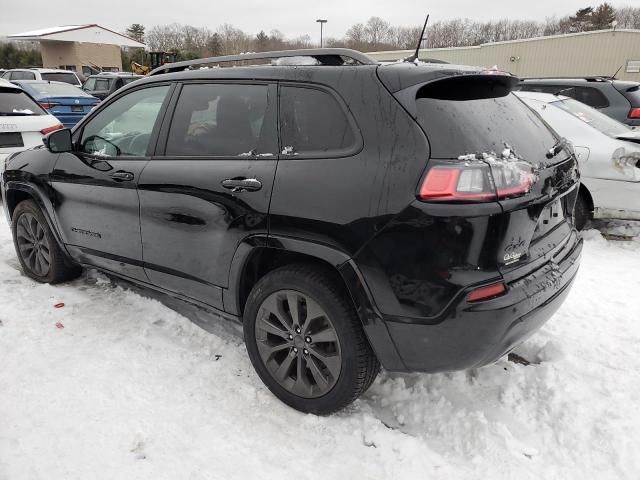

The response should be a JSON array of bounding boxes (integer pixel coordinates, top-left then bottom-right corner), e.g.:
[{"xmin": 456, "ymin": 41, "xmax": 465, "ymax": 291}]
[{"xmin": 516, "ymin": 77, "xmax": 640, "ymax": 126}]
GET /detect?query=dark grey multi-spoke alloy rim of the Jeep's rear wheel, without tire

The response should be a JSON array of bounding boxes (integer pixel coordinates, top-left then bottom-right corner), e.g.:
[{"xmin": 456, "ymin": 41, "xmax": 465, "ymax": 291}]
[{"xmin": 255, "ymin": 290, "xmax": 342, "ymax": 398}]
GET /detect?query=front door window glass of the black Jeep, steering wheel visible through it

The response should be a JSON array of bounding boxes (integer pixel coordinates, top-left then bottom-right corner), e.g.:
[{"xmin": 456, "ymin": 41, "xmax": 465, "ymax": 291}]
[{"xmin": 80, "ymin": 85, "xmax": 169, "ymax": 157}]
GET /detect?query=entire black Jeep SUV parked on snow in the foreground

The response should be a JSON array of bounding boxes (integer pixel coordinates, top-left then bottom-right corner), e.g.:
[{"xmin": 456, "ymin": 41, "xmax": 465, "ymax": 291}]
[{"xmin": 2, "ymin": 49, "xmax": 582, "ymax": 414}]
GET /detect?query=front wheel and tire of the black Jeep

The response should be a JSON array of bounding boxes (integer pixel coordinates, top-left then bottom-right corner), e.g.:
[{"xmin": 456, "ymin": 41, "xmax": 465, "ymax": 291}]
[{"xmin": 11, "ymin": 200, "xmax": 82, "ymax": 283}]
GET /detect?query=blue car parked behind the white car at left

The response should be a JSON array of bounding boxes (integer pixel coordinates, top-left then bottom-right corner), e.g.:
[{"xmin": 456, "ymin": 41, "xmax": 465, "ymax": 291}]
[{"xmin": 12, "ymin": 80, "xmax": 100, "ymax": 128}]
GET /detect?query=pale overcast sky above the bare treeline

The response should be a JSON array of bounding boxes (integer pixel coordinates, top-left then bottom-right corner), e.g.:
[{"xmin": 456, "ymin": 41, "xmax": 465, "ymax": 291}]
[{"xmin": 0, "ymin": 0, "xmax": 640, "ymax": 40}]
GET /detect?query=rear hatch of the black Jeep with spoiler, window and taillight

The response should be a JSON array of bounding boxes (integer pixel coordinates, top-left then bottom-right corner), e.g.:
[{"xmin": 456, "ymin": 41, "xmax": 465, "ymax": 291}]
[{"xmin": 381, "ymin": 67, "xmax": 579, "ymax": 281}]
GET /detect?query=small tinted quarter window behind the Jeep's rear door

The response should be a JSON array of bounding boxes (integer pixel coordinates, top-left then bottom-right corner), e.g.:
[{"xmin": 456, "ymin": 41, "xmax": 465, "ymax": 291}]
[{"xmin": 280, "ymin": 87, "xmax": 356, "ymax": 156}]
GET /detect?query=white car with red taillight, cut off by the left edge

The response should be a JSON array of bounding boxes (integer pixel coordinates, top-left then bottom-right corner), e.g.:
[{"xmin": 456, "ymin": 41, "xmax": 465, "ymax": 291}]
[{"xmin": 0, "ymin": 78, "xmax": 63, "ymax": 169}]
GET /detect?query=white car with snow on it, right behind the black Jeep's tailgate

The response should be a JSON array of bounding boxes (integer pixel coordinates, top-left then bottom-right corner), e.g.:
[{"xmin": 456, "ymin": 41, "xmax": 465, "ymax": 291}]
[{"xmin": 515, "ymin": 92, "xmax": 640, "ymax": 229}]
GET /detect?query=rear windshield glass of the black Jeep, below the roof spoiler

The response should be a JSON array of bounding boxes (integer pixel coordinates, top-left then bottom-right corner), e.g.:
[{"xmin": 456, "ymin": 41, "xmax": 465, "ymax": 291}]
[{"xmin": 416, "ymin": 81, "xmax": 557, "ymax": 164}]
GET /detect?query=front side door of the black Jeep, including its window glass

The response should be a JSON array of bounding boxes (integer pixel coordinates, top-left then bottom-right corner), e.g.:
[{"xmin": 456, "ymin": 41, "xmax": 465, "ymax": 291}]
[{"xmin": 51, "ymin": 85, "xmax": 170, "ymax": 280}]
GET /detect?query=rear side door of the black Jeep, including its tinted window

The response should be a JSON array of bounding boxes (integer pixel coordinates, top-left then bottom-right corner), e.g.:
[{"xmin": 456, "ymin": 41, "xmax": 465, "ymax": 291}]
[{"xmin": 138, "ymin": 82, "xmax": 278, "ymax": 308}]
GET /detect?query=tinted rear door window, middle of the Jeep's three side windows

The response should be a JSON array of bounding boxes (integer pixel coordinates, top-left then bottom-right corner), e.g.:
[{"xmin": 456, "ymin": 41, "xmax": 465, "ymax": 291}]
[{"xmin": 166, "ymin": 84, "xmax": 277, "ymax": 156}]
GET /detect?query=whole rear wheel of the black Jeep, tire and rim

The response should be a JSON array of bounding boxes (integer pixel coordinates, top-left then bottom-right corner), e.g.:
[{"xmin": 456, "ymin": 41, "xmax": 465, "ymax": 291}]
[{"xmin": 244, "ymin": 265, "xmax": 380, "ymax": 415}]
